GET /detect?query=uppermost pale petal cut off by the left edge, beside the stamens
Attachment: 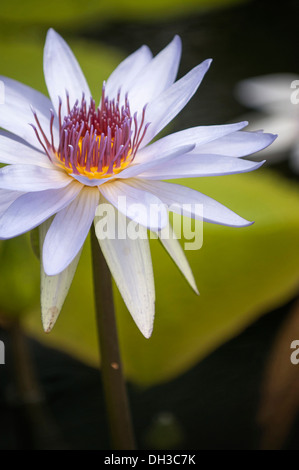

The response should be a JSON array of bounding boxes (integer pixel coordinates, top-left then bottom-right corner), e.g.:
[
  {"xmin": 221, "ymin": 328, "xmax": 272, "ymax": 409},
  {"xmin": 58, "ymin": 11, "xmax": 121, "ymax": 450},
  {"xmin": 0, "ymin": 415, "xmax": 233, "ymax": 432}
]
[{"xmin": 0, "ymin": 76, "xmax": 58, "ymax": 150}]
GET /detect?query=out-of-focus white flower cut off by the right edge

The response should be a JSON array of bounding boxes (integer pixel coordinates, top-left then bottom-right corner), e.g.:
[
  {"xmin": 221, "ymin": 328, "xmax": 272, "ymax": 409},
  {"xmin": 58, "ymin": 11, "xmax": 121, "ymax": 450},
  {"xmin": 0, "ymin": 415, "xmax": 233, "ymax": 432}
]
[{"xmin": 236, "ymin": 73, "xmax": 299, "ymax": 173}]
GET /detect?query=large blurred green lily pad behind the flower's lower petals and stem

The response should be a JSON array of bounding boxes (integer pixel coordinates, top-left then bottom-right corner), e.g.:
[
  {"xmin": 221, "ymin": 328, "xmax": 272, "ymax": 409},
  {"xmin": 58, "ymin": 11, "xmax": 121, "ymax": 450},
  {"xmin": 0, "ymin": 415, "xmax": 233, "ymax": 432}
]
[{"xmin": 27, "ymin": 172, "xmax": 299, "ymax": 385}]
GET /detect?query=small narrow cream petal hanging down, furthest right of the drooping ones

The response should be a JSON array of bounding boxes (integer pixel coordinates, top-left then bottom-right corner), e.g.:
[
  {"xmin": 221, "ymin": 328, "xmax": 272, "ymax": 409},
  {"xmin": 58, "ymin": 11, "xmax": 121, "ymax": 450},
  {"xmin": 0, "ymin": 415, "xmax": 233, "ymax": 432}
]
[{"xmin": 157, "ymin": 224, "xmax": 199, "ymax": 295}]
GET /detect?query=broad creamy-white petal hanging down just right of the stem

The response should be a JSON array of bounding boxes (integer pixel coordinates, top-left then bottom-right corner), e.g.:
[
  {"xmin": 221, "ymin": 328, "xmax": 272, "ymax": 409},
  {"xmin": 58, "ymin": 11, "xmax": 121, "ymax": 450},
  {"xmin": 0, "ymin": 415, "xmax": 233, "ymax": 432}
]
[{"xmin": 95, "ymin": 198, "xmax": 155, "ymax": 338}]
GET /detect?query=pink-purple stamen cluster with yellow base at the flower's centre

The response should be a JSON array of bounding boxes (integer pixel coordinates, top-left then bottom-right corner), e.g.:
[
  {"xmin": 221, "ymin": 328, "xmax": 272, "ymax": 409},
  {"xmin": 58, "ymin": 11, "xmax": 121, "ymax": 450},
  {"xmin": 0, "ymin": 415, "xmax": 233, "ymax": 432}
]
[{"xmin": 32, "ymin": 86, "xmax": 149, "ymax": 175}]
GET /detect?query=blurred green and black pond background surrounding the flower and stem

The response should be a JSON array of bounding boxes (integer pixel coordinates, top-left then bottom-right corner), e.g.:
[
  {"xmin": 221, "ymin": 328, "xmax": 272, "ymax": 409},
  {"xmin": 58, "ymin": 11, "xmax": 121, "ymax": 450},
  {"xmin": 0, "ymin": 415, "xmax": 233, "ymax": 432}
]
[{"xmin": 0, "ymin": 0, "xmax": 299, "ymax": 450}]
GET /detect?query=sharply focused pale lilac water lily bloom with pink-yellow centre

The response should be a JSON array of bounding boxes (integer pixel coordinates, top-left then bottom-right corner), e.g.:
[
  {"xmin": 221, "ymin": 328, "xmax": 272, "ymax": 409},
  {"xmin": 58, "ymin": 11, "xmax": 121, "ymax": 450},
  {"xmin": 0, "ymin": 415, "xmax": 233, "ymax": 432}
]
[{"xmin": 0, "ymin": 29, "xmax": 275, "ymax": 337}]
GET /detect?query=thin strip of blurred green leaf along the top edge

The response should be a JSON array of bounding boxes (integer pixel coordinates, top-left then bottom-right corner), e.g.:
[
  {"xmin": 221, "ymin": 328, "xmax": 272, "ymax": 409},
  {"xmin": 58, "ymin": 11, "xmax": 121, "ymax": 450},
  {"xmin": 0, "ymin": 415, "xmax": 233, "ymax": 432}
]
[{"xmin": 0, "ymin": 0, "xmax": 248, "ymax": 28}]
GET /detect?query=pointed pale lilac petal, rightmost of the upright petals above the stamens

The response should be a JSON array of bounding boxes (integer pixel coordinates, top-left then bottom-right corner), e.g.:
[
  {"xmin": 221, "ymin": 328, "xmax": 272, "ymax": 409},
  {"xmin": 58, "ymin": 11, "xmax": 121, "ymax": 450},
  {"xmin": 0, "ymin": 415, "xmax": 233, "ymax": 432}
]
[{"xmin": 140, "ymin": 59, "xmax": 212, "ymax": 148}]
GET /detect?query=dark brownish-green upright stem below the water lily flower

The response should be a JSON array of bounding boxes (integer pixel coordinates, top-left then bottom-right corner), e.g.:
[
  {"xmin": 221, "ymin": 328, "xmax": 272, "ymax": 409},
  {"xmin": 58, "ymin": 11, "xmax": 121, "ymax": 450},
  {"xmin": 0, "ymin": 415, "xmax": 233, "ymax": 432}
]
[{"xmin": 91, "ymin": 227, "xmax": 135, "ymax": 450}]
